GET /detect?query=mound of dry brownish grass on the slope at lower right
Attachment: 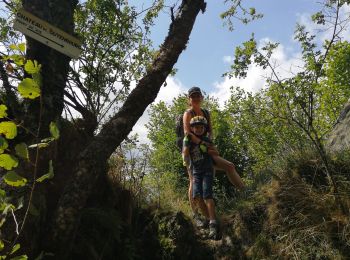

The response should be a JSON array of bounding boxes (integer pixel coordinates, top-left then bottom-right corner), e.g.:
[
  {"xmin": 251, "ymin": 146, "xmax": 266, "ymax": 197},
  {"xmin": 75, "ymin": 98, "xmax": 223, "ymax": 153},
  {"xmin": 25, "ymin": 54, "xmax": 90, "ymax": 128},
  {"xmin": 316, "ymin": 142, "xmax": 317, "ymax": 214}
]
[{"xmin": 216, "ymin": 149, "xmax": 350, "ymax": 259}]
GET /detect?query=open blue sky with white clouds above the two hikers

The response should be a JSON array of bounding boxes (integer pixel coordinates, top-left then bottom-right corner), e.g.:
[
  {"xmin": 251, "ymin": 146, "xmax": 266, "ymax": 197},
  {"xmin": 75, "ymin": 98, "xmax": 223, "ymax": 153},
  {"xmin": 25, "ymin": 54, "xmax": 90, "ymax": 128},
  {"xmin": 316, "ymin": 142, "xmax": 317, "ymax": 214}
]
[{"xmin": 129, "ymin": 0, "xmax": 350, "ymax": 142}]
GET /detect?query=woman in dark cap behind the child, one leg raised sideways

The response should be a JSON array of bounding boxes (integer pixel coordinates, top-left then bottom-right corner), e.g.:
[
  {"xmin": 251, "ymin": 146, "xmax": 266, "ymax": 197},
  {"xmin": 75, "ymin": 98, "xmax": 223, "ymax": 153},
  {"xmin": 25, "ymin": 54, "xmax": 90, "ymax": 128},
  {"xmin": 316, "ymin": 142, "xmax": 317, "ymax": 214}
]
[{"xmin": 183, "ymin": 87, "xmax": 244, "ymax": 226}]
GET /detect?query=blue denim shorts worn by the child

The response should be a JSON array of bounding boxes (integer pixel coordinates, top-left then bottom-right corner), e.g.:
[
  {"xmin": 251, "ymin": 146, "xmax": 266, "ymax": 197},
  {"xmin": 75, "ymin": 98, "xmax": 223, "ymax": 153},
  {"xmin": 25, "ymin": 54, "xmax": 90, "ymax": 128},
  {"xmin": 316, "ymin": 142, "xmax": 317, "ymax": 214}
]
[{"xmin": 192, "ymin": 171, "xmax": 213, "ymax": 199}]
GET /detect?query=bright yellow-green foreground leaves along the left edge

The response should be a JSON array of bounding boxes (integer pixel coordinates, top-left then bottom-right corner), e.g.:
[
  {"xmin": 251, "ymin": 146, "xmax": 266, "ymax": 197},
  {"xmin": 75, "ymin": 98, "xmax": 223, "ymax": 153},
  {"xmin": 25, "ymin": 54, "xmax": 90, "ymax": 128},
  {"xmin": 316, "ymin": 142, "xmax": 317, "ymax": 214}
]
[{"xmin": 0, "ymin": 43, "xmax": 59, "ymax": 259}]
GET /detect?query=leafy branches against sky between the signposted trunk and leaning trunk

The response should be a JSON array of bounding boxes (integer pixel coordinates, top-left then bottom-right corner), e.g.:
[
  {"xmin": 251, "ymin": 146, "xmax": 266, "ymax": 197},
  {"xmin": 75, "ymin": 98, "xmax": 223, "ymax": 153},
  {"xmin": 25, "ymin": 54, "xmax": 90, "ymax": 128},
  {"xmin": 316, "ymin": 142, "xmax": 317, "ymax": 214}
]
[{"xmin": 65, "ymin": 0, "xmax": 163, "ymax": 123}]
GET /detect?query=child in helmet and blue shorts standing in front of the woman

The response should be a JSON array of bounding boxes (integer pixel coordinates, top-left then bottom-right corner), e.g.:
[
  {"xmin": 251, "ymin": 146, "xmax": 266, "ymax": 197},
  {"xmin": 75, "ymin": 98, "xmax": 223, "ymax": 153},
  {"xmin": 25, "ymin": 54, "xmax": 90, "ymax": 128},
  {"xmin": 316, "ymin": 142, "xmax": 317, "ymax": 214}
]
[{"xmin": 183, "ymin": 116, "xmax": 218, "ymax": 239}]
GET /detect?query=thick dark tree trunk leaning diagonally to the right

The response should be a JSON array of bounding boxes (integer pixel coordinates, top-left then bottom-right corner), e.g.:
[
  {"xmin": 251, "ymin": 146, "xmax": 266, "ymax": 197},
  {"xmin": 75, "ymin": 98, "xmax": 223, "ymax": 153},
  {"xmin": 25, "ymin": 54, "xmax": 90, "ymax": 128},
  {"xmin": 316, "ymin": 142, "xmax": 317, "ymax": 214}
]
[{"xmin": 46, "ymin": 0, "xmax": 205, "ymax": 259}]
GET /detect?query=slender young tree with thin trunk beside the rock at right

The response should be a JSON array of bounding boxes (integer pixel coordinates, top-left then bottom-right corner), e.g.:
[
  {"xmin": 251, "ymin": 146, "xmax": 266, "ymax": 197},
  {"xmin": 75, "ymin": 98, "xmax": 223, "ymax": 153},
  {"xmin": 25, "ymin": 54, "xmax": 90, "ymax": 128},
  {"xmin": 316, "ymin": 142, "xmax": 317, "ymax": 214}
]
[{"xmin": 229, "ymin": 1, "xmax": 350, "ymax": 209}]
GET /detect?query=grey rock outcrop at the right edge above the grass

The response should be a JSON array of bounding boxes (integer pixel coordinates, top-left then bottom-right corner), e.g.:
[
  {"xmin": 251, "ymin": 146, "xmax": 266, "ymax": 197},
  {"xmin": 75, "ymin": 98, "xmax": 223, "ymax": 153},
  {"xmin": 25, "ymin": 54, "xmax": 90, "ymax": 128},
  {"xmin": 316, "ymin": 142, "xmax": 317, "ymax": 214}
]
[{"xmin": 326, "ymin": 101, "xmax": 350, "ymax": 152}]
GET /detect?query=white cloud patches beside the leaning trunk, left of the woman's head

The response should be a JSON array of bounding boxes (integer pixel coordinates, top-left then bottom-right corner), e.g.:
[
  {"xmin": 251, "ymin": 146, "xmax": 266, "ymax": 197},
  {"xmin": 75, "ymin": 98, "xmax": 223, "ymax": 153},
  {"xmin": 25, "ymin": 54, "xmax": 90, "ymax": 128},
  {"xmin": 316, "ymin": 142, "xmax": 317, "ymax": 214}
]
[{"xmin": 130, "ymin": 77, "xmax": 187, "ymax": 143}]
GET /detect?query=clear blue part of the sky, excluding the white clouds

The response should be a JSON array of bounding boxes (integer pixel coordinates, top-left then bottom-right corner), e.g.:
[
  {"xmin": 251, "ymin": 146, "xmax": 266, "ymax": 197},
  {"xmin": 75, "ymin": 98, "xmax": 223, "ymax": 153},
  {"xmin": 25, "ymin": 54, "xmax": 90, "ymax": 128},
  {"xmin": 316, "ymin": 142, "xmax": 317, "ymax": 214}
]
[{"xmin": 145, "ymin": 0, "xmax": 319, "ymax": 92}]
